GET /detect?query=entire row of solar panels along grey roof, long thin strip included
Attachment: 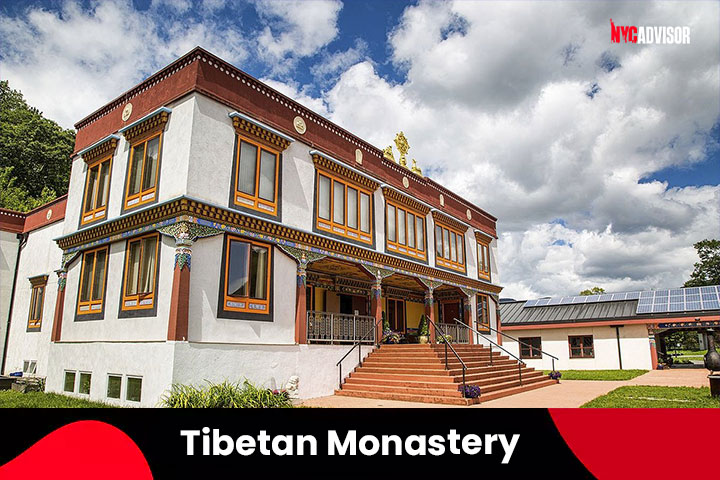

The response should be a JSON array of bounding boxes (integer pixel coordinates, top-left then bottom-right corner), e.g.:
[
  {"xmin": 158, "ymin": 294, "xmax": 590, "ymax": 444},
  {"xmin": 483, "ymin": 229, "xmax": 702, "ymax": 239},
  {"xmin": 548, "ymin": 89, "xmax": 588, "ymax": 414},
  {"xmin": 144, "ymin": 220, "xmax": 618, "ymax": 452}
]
[{"xmin": 523, "ymin": 286, "xmax": 720, "ymax": 314}]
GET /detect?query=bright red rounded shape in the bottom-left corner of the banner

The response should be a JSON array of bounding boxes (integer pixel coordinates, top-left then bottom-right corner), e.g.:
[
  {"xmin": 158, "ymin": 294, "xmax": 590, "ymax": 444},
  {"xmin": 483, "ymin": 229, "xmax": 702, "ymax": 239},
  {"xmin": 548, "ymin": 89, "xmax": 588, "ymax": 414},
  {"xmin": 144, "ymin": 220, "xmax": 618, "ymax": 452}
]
[{"xmin": 0, "ymin": 420, "xmax": 152, "ymax": 480}]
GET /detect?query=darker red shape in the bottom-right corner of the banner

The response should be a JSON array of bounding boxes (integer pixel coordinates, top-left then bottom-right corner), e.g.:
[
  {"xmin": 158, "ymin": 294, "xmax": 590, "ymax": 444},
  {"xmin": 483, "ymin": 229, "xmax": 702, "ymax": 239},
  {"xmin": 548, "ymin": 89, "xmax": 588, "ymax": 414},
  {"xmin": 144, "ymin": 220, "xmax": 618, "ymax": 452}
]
[{"xmin": 550, "ymin": 409, "xmax": 720, "ymax": 480}]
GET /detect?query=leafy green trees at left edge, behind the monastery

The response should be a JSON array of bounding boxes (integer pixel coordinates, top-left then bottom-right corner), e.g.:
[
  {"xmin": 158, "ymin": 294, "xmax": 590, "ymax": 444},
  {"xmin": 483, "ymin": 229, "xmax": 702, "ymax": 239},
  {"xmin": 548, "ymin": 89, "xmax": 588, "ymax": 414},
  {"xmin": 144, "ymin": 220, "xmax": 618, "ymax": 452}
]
[{"xmin": 0, "ymin": 80, "xmax": 75, "ymax": 210}]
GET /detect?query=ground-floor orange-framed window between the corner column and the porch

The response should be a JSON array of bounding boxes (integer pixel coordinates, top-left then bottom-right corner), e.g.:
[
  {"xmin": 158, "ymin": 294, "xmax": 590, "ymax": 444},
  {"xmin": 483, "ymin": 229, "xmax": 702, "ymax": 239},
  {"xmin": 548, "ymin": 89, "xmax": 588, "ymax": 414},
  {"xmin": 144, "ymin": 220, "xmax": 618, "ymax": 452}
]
[{"xmin": 223, "ymin": 236, "xmax": 272, "ymax": 314}]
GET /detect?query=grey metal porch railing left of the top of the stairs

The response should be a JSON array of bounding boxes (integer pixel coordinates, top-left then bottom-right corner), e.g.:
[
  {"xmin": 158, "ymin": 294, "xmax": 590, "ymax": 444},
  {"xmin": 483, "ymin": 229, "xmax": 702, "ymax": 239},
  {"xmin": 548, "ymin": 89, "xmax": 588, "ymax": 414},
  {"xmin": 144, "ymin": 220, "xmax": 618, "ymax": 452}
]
[{"xmin": 307, "ymin": 311, "xmax": 378, "ymax": 345}]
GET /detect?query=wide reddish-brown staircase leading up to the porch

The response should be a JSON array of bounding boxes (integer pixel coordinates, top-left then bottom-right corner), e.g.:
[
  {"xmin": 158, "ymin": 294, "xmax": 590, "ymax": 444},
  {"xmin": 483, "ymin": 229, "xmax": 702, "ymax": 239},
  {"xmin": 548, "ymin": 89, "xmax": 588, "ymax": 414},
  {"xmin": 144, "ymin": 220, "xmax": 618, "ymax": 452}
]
[{"xmin": 335, "ymin": 344, "xmax": 557, "ymax": 405}]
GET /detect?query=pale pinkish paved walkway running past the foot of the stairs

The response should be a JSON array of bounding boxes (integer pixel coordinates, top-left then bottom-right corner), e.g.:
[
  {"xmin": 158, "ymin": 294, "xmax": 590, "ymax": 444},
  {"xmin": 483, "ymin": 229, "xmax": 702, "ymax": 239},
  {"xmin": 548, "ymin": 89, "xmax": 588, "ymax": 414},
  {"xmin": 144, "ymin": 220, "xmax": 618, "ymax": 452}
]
[{"xmin": 303, "ymin": 368, "xmax": 708, "ymax": 408}]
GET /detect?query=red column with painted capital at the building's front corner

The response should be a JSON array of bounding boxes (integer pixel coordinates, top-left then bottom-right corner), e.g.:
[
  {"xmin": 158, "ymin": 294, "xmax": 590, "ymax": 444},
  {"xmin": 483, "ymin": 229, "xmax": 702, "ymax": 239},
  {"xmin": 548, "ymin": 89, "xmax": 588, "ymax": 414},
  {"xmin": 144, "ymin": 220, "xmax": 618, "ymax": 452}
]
[{"xmin": 158, "ymin": 221, "xmax": 223, "ymax": 342}]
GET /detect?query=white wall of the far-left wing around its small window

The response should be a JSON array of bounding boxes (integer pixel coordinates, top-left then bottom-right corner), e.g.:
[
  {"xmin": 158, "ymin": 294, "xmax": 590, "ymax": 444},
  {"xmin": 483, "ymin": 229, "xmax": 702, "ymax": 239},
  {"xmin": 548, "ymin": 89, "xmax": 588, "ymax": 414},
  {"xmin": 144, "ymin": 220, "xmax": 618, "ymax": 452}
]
[{"xmin": 3, "ymin": 222, "xmax": 63, "ymax": 376}]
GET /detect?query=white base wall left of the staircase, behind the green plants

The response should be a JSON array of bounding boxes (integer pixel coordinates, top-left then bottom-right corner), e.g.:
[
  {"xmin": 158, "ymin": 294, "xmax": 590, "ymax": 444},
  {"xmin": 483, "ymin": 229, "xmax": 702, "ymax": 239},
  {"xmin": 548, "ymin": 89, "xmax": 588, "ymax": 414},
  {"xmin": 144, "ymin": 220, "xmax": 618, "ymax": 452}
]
[{"xmin": 173, "ymin": 342, "xmax": 371, "ymax": 398}]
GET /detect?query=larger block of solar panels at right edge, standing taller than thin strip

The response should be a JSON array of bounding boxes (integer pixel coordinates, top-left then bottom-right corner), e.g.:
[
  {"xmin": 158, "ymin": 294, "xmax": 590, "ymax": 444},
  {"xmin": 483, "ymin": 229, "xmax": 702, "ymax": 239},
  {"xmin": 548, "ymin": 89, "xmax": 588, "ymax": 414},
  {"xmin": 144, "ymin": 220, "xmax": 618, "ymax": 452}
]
[{"xmin": 637, "ymin": 286, "xmax": 720, "ymax": 313}]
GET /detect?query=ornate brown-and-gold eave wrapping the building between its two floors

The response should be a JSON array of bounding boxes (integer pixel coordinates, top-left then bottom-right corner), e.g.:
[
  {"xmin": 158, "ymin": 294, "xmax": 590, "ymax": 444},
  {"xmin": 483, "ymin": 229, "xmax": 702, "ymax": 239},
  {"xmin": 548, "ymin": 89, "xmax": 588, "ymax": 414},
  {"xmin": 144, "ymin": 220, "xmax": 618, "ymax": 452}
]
[{"xmin": 56, "ymin": 197, "xmax": 502, "ymax": 294}]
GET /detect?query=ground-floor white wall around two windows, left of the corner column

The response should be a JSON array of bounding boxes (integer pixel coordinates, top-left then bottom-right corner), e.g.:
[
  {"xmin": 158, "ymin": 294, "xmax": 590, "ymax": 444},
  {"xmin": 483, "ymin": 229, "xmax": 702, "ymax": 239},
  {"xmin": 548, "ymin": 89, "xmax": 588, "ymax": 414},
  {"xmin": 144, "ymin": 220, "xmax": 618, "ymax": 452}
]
[{"xmin": 58, "ymin": 235, "xmax": 175, "ymax": 342}]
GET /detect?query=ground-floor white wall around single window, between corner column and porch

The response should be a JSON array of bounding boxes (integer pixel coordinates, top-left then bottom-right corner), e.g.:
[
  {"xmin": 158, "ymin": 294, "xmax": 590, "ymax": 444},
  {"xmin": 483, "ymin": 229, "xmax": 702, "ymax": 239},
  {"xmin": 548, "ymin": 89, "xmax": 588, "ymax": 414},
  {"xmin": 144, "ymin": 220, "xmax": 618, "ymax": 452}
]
[{"xmin": 188, "ymin": 239, "xmax": 297, "ymax": 345}]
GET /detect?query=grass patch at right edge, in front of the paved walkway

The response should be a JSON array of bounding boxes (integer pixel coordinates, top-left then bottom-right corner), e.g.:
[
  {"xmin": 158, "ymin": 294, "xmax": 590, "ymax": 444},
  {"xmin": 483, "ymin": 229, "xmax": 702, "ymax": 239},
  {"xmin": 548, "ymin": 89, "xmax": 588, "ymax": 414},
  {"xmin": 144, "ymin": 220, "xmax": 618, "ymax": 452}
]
[{"xmin": 580, "ymin": 386, "xmax": 720, "ymax": 408}]
